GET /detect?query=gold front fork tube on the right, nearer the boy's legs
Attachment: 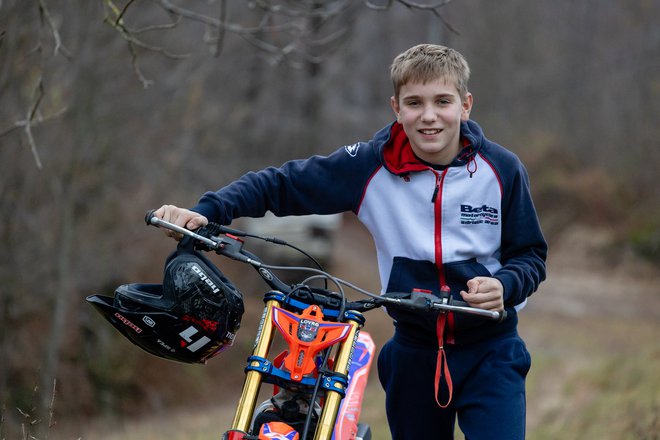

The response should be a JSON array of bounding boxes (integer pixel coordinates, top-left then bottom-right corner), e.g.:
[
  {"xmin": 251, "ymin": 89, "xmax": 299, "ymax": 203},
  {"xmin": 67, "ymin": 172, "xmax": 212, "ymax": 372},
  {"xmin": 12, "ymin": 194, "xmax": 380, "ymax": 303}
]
[{"xmin": 314, "ymin": 319, "xmax": 361, "ymax": 440}]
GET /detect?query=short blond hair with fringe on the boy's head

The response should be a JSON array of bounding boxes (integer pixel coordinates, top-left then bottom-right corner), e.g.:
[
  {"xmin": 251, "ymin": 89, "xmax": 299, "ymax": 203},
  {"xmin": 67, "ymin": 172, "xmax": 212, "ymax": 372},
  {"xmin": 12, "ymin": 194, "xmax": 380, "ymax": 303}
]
[{"xmin": 390, "ymin": 44, "xmax": 470, "ymax": 101}]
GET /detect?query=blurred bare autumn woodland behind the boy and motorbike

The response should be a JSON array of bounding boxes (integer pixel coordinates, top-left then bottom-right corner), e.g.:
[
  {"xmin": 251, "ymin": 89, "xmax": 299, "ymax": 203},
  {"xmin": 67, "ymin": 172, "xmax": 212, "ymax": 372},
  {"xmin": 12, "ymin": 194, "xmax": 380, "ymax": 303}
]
[{"xmin": 0, "ymin": 0, "xmax": 660, "ymax": 439}]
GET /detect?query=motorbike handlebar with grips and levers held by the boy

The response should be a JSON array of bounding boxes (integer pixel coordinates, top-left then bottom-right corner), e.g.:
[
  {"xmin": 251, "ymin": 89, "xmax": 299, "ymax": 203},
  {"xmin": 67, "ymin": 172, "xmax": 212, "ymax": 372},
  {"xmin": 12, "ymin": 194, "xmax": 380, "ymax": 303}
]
[{"xmin": 145, "ymin": 210, "xmax": 507, "ymax": 322}]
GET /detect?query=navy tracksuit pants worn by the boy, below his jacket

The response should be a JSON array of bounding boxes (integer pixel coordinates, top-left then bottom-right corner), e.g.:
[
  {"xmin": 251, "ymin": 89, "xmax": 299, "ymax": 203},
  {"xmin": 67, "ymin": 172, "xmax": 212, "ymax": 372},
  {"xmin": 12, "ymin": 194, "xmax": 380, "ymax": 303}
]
[{"xmin": 378, "ymin": 330, "xmax": 531, "ymax": 440}]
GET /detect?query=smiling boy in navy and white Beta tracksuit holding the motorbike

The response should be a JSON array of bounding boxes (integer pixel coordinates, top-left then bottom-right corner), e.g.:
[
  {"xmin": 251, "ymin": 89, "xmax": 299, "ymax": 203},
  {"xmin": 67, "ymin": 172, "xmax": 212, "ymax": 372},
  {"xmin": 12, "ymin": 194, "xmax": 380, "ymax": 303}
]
[{"xmin": 156, "ymin": 44, "xmax": 547, "ymax": 440}]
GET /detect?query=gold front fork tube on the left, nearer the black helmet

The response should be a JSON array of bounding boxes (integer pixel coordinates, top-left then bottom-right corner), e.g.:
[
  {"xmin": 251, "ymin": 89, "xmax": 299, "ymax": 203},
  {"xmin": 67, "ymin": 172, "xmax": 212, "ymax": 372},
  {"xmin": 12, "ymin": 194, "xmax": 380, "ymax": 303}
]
[{"xmin": 231, "ymin": 300, "xmax": 280, "ymax": 432}]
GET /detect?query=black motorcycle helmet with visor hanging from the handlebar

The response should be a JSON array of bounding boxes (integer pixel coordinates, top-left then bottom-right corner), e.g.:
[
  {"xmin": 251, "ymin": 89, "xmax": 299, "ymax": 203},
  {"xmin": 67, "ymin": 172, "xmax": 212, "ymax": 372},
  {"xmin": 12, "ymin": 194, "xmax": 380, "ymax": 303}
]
[{"xmin": 87, "ymin": 237, "xmax": 243, "ymax": 363}]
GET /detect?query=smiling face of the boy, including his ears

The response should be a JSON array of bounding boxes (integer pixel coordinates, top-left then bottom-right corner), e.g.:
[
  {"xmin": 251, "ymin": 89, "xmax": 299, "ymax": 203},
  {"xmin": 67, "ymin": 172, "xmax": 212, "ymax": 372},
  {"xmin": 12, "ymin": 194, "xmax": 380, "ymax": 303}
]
[{"xmin": 391, "ymin": 78, "xmax": 472, "ymax": 165}]
